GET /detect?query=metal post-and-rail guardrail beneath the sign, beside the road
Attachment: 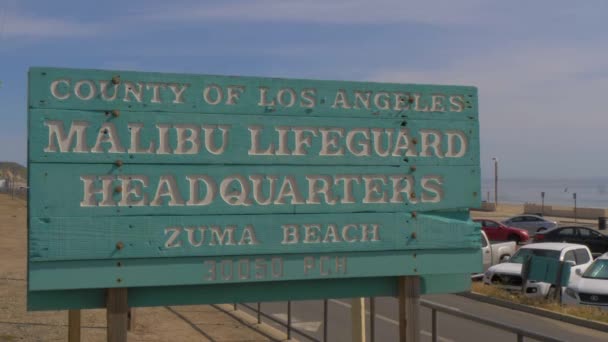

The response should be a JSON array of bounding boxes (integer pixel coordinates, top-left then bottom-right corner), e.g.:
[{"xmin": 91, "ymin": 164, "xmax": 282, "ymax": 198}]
[{"xmin": 234, "ymin": 297, "xmax": 564, "ymax": 342}]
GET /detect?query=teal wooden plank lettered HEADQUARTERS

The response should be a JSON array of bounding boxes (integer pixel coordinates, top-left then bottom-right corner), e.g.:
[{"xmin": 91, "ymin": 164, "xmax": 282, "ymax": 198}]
[{"xmin": 29, "ymin": 163, "xmax": 480, "ymax": 217}]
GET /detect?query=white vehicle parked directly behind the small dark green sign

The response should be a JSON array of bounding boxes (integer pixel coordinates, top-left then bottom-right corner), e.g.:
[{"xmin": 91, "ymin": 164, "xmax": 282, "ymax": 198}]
[{"xmin": 483, "ymin": 243, "xmax": 593, "ymax": 297}]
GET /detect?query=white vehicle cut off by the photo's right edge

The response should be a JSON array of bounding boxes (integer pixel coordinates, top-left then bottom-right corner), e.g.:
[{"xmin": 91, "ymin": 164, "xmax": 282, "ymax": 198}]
[{"xmin": 562, "ymin": 253, "xmax": 608, "ymax": 310}]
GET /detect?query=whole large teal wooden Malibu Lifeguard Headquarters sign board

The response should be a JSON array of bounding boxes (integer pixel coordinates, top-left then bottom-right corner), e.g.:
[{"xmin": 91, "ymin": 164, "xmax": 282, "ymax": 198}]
[{"xmin": 28, "ymin": 68, "xmax": 481, "ymax": 310}]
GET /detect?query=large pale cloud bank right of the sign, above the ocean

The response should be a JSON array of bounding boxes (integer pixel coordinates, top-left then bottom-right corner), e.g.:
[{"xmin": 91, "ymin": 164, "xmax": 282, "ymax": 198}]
[{"xmin": 370, "ymin": 44, "xmax": 608, "ymax": 177}]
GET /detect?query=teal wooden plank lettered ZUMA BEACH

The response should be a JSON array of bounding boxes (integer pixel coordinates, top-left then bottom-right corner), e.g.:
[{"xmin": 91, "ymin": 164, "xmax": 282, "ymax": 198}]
[{"xmin": 29, "ymin": 213, "xmax": 480, "ymax": 262}]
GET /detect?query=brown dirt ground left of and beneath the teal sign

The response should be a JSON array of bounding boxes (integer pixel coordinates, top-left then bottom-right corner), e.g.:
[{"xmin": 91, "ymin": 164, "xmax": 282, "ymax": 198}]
[{"xmin": 0, "ymin": 194, "xmax": 270, "ymax": 342}]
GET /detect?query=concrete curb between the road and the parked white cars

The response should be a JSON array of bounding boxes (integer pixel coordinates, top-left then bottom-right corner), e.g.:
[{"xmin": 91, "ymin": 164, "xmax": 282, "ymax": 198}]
[{"xmin": 458, "ymin": 292, "xmax": 608, "ymax": 332}]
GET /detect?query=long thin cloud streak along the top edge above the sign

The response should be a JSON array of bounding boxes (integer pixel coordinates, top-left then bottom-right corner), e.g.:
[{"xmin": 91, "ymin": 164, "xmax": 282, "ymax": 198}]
[{"xmin": 142, "ymin": 0, "xmax": 490, "ymax": 25}]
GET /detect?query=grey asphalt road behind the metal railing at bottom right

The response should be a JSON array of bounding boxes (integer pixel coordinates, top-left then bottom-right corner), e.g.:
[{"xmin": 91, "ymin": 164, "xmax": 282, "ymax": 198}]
[{"xmin": 240, "ymin": 295, "xmax": 608, "ymax": 342}]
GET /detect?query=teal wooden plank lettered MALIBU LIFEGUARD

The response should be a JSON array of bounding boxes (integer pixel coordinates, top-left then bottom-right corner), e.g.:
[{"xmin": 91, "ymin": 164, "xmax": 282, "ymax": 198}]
[{"xmin": 29, "ymin": 109, "xmax": 479, "ymax": 165}]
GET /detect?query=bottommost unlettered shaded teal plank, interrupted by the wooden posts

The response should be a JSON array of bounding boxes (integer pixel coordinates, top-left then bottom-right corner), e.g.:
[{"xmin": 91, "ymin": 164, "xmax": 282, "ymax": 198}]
[{"xmin": 27, "ymin": 273, "xmax": 471, "ymax": 310}]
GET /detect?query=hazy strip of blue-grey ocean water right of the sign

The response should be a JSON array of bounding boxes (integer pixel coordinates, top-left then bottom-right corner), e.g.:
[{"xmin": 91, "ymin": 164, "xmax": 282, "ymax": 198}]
[{"xmin": 481, "ymin": 177, "xmax": 608, "ymax": 208}]
